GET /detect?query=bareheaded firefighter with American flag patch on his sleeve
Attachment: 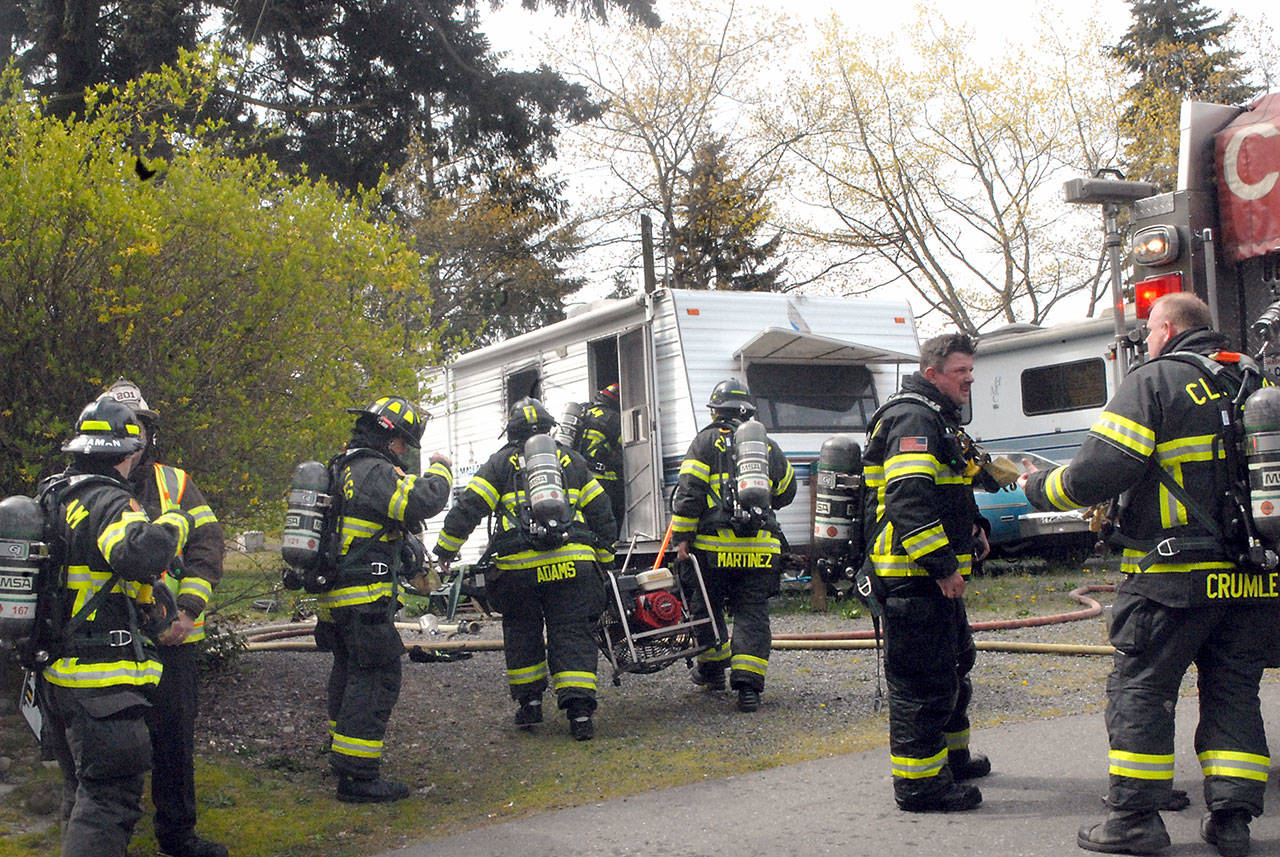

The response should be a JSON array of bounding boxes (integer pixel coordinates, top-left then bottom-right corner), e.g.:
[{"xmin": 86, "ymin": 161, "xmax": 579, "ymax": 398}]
[{"xmin": 863, "ymin": 334, "xmax": 997, "ymax": 812}]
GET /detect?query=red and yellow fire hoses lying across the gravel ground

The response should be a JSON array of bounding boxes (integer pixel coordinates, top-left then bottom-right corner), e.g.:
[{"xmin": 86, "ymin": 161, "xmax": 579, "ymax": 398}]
[{"xmin": 244, "ymin": 585, "xmax": 1115, "ymax": 655}]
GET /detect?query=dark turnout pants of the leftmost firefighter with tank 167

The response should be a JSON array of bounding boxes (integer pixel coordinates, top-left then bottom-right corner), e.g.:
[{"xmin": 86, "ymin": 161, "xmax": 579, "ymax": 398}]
[{"xmin": 40, "ymin": 680, "xmax": 151, "ymax": 857}]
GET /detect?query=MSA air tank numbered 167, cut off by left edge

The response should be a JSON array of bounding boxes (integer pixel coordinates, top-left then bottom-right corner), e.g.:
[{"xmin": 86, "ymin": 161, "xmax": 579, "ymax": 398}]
[{"xmin": 0, "ymin": 495, "xmax": 49, "ymax": 640}]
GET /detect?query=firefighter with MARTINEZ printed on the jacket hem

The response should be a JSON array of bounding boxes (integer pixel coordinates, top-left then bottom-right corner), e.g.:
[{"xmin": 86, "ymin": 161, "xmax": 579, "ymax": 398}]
[{"xmin": 671, "ymin": 379, "xmax": 796, "ymax": 711}]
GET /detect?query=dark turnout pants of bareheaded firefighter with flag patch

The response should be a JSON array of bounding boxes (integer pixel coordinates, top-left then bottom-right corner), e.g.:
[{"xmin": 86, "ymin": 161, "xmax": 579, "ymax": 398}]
[{"xmin": 884, "ymin": 581, "xmax": 977, "ymax": 799}]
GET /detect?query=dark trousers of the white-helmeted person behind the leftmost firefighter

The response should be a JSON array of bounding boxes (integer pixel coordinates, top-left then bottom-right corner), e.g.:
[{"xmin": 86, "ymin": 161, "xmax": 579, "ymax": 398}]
[{"xmin": 147, "ymin": 643, "xmax": 200, "ymax": 845}]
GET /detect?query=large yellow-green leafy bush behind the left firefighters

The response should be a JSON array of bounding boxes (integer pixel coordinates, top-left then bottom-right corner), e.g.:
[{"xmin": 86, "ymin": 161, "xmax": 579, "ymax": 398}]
[{"xmin": 0, "ymin": 63, "xmax": 433, "ymax": 521}]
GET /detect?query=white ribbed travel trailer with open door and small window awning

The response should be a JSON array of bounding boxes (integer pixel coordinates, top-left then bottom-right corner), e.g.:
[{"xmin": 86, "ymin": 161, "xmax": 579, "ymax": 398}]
[{"xmin": 422, "ymin": 289, "xmax": 919, "ymax": 563}]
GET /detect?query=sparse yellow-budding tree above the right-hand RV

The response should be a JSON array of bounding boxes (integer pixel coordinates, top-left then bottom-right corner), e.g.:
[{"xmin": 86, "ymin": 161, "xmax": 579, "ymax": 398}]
[{"xmin": 777, "ymin": 9, "xmax": 1126, "ymax": 333}]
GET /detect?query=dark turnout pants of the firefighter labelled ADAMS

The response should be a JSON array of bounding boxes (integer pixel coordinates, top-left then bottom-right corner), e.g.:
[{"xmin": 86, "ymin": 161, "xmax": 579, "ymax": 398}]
[{"xmin": 486, "ymin": 560, "xmax": 604, "ymax": 711}]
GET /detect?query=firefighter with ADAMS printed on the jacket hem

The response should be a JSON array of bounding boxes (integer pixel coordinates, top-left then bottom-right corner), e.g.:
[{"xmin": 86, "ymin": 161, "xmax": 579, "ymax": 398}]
[{"xmin": 433, "ymin": 398, "xmax": 617, "ymax": 741}]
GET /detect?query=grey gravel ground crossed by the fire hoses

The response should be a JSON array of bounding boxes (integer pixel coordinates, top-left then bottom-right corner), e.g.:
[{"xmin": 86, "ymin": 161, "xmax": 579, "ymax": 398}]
[{"xmin": 197, "ymin": 595, "xmax": 1111, "ymax": 788}]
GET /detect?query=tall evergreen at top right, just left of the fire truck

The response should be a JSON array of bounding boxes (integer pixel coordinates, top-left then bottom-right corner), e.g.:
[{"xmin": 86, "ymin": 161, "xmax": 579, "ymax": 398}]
[{"xmin": 1112, "ymin": 0, "xmax": 1256, "ymax": 189}]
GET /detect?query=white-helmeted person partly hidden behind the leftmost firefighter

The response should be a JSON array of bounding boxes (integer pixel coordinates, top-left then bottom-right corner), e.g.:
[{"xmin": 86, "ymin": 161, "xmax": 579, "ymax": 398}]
[{"xmin": 104, "ymin": 377, "xmax": 227, "ymax": 857}]
